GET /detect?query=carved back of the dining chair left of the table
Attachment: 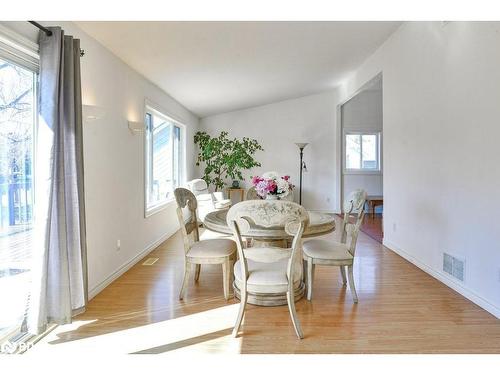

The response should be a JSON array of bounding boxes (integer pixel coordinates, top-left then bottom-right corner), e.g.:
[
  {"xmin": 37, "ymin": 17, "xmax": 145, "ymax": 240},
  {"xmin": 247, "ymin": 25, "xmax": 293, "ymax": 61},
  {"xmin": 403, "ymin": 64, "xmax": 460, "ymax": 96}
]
[{"xmin": 174, "ymin": 188, "xmax": 200, "ymax": 253}]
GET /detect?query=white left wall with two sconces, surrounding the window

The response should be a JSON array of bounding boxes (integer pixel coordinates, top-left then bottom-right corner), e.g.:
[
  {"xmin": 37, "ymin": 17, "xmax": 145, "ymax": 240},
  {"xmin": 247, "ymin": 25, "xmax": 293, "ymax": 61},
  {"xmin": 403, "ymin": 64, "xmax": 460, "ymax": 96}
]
[{"xmin": 3, "ymin": 22, "xmax": 198, "ymax": 296}]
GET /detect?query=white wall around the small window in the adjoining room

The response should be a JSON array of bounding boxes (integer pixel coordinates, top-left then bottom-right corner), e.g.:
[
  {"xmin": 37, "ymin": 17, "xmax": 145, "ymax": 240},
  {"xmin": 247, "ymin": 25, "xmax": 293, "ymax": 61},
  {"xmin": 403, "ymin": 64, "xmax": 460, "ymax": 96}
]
[{"xmin": 342, "ymin": 88, "xmax": 383, "ymax": 201}]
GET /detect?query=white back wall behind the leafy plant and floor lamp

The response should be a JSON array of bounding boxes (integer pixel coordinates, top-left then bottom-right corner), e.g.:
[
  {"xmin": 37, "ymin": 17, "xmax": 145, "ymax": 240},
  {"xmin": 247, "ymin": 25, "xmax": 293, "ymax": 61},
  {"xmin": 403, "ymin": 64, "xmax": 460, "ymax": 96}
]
[{"xmin": 200, "ymin": 91, "xmax": 339, "ymax": 211}]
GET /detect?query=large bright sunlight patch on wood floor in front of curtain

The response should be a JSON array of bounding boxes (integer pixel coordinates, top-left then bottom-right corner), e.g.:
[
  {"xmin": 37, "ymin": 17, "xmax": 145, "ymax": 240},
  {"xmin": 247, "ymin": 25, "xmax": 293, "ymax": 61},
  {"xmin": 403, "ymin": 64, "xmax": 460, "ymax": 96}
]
[{"xmin": 26, "ymin": 304, "xmax": 241, "ymax": 356}]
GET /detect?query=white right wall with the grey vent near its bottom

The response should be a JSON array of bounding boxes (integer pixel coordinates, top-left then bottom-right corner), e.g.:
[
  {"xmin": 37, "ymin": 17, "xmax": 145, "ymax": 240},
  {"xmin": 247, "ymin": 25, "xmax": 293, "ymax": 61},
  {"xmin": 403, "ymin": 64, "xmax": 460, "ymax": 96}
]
[{"xmin": 342, "ymin": 22, "xmax": 500, "ymax": 317}]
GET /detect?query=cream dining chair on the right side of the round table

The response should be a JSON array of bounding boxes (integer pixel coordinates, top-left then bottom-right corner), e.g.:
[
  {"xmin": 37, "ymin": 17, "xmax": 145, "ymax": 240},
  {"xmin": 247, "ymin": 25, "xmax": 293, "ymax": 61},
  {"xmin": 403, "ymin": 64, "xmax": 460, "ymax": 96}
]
[{"xmin": 302, "ymin": 189, "xmax": 366, "ymax": 303}]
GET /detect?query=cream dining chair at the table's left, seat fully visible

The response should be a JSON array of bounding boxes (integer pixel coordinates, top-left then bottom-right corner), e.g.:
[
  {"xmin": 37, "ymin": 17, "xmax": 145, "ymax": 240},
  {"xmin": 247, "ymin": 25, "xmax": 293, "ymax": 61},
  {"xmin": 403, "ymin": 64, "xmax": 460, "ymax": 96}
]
[{"xmin": 174, "ymin": 188, "xmax": 236, "ymax": 300}]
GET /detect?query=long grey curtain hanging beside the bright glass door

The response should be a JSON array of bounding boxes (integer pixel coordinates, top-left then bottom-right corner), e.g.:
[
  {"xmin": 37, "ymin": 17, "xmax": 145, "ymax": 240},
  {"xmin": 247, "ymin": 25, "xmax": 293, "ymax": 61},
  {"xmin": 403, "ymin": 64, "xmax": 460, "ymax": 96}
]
[{"xmin": 27, "ymin": 27, "xmax": 87, "ymax": 334}]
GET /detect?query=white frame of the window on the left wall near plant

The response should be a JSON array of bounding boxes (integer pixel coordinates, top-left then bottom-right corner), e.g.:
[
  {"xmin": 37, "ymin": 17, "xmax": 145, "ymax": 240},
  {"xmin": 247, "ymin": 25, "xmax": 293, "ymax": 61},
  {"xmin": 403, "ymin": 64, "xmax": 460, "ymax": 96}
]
[{"xmin": 143, "ymin": 99, "xmax": 186, "ymax": 218}]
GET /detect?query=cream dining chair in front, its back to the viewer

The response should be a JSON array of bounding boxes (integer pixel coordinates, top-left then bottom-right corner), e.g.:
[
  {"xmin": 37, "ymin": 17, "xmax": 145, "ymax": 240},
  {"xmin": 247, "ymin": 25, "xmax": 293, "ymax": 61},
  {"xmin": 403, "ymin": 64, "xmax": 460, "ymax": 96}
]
[{"xmin": 227, "ymin": 200, "xmax": 309, "ymax": 338}]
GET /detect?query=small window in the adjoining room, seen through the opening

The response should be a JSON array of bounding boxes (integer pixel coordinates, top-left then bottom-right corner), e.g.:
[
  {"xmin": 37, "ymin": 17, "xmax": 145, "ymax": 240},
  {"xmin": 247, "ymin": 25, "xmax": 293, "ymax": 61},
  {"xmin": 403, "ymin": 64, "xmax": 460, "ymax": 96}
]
[{"xmin": 345, "ymin": 132, "xmax": 380, "ymax": 171}]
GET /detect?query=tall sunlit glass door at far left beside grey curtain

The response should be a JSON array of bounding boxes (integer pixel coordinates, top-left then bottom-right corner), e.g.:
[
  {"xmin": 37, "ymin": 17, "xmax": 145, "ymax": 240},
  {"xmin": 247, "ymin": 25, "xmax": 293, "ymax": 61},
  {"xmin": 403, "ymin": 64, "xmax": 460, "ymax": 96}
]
[{"xmin": 0, "ymin": 55, "xmax": 37, "ymax": 340}]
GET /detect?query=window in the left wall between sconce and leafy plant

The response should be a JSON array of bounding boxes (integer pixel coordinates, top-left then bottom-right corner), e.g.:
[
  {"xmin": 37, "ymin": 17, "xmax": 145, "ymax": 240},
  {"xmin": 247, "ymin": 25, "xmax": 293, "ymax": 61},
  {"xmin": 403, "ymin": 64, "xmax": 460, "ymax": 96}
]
[{"xmin": 145, "ymin": 106, "xmax": 184, "ymax": 215}]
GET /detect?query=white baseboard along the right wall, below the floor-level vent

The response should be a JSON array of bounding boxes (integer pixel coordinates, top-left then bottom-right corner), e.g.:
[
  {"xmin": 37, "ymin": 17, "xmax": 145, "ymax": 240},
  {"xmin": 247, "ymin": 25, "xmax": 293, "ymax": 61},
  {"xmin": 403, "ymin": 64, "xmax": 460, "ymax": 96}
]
[{"xmin": 383, "ymin": 239, "xmax": 500, "ymax": 319}]
